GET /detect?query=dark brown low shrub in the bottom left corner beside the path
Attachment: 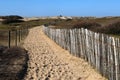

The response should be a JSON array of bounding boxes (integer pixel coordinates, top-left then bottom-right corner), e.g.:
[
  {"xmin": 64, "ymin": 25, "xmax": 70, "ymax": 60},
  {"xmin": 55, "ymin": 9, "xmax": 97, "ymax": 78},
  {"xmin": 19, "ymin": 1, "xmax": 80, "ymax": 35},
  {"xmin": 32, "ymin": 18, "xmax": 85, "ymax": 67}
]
[{"xmin": 0, "ymin": 46, "xmax": 28, "ymax": 80}]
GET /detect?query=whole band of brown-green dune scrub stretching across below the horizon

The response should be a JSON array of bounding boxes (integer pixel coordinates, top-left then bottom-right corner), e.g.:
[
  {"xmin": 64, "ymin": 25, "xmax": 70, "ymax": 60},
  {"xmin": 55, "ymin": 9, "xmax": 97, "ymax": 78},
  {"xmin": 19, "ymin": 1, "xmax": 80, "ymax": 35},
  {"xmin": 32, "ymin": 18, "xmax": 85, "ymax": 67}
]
[{"xmin": 0, "ymin": 16, "xmax": 120, "ymax": 35}]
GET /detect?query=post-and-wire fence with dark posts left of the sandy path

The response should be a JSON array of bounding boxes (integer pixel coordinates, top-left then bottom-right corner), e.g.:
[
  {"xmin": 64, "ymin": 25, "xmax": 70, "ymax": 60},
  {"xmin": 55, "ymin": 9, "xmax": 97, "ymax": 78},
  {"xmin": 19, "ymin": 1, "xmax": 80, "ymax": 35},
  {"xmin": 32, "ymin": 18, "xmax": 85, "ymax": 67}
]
[{"xmin": 0, "ymin": 29, "xmax": 28, "ymax": 48}]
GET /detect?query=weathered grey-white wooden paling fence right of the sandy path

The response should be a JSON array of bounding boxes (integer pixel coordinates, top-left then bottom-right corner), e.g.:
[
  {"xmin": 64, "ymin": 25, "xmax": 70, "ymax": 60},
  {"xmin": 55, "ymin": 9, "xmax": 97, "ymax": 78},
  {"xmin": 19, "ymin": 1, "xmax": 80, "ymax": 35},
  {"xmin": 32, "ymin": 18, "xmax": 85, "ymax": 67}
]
[{"xmin": 43, "ymin": 26, "xmax": 120, "ymax": 80}]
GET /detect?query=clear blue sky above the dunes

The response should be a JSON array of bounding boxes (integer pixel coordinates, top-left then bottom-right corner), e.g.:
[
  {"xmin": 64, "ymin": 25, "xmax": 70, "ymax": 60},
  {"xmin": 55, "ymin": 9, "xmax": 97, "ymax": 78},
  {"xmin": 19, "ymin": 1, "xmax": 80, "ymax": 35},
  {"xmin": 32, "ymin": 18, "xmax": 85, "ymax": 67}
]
[{"xmin": 0, "ymin": 0, "xmax": 120, "ymax": 17}]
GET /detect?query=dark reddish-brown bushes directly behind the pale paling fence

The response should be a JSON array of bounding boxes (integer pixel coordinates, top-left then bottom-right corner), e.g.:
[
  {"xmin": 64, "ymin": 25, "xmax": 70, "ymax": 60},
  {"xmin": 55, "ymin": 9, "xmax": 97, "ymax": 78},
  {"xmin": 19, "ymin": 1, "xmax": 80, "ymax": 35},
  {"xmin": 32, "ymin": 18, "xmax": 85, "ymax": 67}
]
[{"xmin": 73, "ymin": 21, "xmax": 120, "ymax": 35}]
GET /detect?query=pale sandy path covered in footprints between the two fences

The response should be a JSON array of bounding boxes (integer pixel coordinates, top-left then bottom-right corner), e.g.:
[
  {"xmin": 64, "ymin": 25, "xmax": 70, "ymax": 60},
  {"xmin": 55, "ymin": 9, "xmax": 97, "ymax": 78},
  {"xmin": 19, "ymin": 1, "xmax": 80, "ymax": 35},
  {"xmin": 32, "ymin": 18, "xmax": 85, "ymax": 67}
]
[{"xmin": 23, "ymin": 26, "xmax": 105, "ymax": 80}]
